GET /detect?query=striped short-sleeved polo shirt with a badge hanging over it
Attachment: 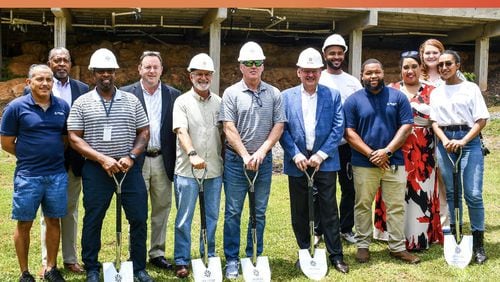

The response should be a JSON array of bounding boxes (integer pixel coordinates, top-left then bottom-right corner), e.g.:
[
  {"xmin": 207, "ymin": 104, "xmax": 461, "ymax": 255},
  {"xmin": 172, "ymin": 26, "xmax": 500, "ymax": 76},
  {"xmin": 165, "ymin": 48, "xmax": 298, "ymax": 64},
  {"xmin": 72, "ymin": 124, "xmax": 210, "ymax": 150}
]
[{"xmin": 67, "ymin": 89, "xmax": 148, "ymax": 158}]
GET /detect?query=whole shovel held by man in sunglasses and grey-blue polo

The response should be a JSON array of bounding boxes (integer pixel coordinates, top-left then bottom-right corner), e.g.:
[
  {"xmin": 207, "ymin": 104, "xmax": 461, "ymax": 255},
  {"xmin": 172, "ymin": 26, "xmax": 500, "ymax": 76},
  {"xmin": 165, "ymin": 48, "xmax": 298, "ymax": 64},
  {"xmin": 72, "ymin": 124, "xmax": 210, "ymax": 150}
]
[{"xmin": 241, "ymin": 164, "xmax": 271, "ymax": 281}]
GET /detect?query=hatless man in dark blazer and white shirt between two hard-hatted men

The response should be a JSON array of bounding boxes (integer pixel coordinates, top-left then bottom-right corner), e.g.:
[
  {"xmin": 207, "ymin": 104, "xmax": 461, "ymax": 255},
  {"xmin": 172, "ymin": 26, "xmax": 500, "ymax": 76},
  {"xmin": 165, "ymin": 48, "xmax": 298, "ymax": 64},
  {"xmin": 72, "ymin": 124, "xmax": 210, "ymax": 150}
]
[{"xmin": 120, "ymin": 51, "xmax": 181, "ymax": 270}]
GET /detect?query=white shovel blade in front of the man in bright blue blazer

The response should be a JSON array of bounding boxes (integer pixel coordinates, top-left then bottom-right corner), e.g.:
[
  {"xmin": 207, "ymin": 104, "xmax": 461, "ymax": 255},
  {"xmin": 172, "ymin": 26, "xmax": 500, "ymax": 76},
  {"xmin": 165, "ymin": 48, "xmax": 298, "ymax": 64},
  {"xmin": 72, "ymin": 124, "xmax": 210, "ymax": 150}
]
[{"xmin": 299, "ymin": 249, "xmax": 328, "ymax": 281}]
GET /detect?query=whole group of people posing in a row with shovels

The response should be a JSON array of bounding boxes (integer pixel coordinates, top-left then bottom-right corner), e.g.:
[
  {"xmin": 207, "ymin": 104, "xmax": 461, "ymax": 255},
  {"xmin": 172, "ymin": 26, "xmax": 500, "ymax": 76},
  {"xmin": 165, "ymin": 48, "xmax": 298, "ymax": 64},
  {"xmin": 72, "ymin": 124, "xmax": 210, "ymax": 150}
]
[{"xmin": 0, "ymin": 34, "xmax": 489, "ymax": 282}]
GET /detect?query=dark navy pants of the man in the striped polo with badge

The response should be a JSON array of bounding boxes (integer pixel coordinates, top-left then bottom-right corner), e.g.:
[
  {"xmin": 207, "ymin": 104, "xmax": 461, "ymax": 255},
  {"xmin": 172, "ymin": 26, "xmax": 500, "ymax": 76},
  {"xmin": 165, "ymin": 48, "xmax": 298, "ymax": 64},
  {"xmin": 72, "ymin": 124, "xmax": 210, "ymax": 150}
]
[{"xmin": 82, "ymin": 161, "xmax": 148, "ymax": 273}]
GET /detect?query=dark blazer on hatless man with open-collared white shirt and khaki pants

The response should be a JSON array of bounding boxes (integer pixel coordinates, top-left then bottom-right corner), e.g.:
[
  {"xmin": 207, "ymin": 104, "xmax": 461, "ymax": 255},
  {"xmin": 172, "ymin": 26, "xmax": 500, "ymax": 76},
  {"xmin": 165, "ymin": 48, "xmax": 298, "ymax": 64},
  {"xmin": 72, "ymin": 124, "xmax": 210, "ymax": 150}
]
[{"xmin": 120, "ymin": 81, "xmax": 181, "ymax": 181}]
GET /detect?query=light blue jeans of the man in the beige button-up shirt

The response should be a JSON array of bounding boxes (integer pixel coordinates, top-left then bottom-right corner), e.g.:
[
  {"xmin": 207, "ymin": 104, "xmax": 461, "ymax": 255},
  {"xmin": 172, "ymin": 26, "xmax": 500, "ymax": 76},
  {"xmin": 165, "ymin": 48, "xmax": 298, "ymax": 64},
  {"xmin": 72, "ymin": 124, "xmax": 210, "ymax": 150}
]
[{"xmin": 174, "ymin": 175, "xmax": 222, "ymax": 265}]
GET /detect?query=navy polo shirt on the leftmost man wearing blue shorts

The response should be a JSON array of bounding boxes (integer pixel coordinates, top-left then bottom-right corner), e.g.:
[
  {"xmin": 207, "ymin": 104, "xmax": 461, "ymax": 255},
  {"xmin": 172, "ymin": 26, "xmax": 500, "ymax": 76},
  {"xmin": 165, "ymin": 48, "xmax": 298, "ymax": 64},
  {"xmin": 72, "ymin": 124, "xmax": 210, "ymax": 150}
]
[{"xmin": 0, "ymin": 94, "xmax": 70, "ymax": 176}]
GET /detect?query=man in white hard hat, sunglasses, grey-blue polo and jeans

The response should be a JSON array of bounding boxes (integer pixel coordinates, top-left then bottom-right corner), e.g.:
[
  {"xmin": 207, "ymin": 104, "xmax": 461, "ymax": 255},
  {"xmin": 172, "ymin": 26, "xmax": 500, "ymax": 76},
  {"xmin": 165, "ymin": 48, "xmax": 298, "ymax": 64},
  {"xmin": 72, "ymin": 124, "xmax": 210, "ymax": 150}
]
[{"xmin": 219, "ymin": 41, "xmax": 286, "ymax": 279}]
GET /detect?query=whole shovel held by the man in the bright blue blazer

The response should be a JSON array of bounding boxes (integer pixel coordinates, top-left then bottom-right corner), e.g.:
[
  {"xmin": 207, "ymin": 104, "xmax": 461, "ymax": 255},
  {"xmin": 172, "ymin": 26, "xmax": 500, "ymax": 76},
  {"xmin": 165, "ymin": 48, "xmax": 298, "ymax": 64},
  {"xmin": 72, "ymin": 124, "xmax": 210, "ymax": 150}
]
[{"xmin": 299, "ymin": 169, "xmax": 328, "ymax": 280}]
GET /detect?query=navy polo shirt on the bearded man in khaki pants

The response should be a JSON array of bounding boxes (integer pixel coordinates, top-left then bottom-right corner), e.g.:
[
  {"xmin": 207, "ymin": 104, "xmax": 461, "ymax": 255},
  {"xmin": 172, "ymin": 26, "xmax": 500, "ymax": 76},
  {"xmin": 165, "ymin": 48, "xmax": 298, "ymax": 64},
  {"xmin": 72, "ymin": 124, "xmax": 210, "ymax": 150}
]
[{"xmin": 344, "ymin": 87, "xmax": 413, "ymax": 167}]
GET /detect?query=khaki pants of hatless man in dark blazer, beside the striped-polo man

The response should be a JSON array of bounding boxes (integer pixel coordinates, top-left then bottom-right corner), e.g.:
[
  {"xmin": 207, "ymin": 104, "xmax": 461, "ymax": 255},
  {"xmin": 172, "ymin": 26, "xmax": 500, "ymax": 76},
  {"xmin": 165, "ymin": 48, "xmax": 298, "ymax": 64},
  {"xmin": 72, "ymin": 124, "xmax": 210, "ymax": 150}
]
[{"xmin": 142, "ymin": 155, "xmax": 172, "ymax": 258}]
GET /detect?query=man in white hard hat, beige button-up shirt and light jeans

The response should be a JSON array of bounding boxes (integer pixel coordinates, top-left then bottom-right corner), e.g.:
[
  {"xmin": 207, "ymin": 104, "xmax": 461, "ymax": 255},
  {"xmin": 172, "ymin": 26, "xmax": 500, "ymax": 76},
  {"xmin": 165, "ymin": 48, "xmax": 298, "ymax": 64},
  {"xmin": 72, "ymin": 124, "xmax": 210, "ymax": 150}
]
[{"xmin": 172, "ymin": 53, "xmax": 222, "ymax": 278}]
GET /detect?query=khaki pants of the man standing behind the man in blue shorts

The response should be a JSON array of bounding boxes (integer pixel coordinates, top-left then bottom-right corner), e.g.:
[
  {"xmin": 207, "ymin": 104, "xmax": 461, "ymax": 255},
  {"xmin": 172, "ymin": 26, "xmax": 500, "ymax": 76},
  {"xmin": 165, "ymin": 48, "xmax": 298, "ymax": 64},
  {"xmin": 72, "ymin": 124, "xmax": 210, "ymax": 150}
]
[{"xmin": 40, "ymin": 167, "xmax": 82, "ymax": 265}]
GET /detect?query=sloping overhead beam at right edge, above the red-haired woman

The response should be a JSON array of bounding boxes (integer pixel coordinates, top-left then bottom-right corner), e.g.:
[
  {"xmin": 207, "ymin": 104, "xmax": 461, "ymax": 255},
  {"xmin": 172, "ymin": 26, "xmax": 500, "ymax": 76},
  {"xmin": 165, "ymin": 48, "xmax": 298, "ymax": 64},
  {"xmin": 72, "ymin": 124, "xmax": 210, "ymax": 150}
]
[{"xmin": 443, "ymin": 21, "xmax": 500, "ymax": 44}]
